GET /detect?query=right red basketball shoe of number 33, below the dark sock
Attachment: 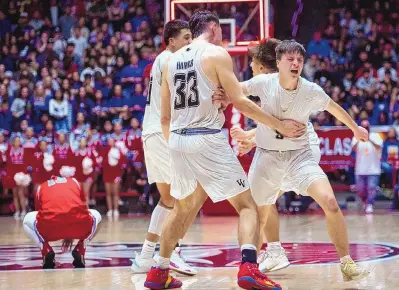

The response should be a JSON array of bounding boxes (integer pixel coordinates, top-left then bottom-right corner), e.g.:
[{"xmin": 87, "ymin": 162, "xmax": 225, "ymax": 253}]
[{"xmin": 237, "ymin": 263, "xmax": 282, "ymax": 290}]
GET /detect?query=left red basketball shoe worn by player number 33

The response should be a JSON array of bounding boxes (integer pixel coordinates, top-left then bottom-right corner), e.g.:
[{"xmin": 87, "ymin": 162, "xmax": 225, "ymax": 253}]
[{"xmin": 144, "ymin": 266, "xmax": 183, "ymax": 289}]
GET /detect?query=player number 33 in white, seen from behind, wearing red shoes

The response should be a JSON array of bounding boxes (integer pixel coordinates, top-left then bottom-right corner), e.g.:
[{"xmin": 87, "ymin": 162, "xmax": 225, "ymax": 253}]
[{"xmin": 144, "ymin": 11, "xmax": 306, "ymax": 289}]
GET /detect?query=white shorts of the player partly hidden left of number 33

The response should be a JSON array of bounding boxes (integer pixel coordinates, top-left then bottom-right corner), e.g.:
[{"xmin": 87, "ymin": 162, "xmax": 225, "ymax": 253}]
[{"xmin": 143, "ymin": 133, "xmax": 170, "ymax": 184}]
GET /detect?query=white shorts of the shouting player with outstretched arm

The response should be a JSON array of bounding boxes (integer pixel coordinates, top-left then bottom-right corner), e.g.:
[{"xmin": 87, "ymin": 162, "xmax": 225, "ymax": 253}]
[{"xmin": 248, "ymin": 147, "xmax": 327, "ymax": 206}]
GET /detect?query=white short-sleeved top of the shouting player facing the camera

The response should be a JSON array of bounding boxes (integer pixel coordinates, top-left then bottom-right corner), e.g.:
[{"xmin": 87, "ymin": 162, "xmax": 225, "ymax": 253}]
[{"xmin": 245, "ymin": 73, "xmax": 330, "ymax": 151}]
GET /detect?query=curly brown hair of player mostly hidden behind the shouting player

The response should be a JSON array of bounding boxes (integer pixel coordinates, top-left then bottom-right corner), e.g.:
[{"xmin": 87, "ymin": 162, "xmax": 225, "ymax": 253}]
[{"xmin": 248, "ymin": 38, "xmax": 281, "ymax": 72}]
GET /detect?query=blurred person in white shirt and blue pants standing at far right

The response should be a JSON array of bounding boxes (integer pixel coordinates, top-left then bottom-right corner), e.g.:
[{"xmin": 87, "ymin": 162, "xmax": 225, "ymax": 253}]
[{"xmin": 352, "ymin": 120, "xmax": 383, "ymax": 213}]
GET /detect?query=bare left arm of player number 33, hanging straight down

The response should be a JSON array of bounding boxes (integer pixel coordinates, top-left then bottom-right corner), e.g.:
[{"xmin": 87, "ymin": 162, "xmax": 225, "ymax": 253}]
[{"xmin": 161, "ymin": 64, "xmax": 171, "ymax": 142}]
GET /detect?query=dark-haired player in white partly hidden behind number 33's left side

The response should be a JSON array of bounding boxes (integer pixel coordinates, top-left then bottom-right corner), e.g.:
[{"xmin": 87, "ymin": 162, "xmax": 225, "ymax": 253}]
[{"xmin": 131, "ymin": 20, "xmax": 197, "ymax": 275}]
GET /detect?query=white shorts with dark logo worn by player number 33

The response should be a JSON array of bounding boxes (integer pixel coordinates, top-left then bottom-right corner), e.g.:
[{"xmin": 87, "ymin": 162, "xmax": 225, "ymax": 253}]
[{"xmin": 169, "ymin": 133, "xmax": 249, "ymax": 202}]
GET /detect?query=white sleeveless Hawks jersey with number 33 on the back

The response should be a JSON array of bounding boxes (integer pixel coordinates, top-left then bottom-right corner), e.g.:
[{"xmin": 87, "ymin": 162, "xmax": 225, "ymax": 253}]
[{"xmin": 168, "ymin": 42, "xmax": 224, "ymax": 131}]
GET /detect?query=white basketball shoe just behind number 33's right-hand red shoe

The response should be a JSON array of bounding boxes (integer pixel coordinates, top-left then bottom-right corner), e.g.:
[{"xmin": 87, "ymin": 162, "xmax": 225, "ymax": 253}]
[{"xmin": 258, "ymin": 248, "xmax": 290, "ymax": 273}]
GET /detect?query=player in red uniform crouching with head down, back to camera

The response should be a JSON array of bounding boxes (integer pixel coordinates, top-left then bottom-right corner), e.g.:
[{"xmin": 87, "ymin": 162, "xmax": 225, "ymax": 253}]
[{"xmin": 24, "ymin": 176, "xmax": 101, "ymax": 269}]
